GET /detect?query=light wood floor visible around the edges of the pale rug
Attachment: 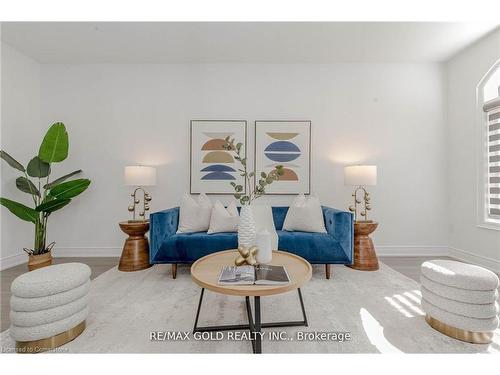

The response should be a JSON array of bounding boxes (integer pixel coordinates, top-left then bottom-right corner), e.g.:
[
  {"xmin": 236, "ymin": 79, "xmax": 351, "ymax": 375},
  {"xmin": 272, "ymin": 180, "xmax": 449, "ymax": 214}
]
[{"xmin": 0, "ymin": 257, "xmax": 458, "ymax": 331}]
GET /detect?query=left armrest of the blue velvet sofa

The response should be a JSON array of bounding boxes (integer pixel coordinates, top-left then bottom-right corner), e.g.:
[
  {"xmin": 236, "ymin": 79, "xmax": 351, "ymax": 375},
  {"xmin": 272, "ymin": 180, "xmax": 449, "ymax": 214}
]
[{"xmin": 149, "ymin": 207, "xmax": 179, "ymax": 263}]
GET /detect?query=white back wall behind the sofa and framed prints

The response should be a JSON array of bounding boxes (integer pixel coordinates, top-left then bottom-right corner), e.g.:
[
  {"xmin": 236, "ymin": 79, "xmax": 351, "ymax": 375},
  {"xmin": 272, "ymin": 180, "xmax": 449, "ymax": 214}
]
[{"xmin": 34, "ymin": 64, "xmax": 447, "ymax": 255}]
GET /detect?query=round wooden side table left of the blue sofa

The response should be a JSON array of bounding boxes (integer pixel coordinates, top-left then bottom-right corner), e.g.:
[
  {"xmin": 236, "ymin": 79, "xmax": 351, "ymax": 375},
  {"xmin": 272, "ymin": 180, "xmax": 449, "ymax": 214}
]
[{"xmin": 118, "ymin": 221, "xmax": 152, "ymax": 272}]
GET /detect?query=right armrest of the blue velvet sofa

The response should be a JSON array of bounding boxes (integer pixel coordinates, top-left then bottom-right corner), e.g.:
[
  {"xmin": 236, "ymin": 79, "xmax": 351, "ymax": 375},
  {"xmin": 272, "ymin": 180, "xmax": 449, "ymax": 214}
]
[{"xmin": 322, "ymin": 206, "xmax": 354, "ymax": 259}]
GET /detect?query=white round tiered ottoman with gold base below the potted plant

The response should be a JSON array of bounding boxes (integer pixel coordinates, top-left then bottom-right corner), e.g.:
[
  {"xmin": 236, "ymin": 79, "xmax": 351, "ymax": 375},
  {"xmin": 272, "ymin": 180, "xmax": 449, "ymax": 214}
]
[{"xmin": 10, "ymin": 263, "xmax": 91, "ymax": 353}]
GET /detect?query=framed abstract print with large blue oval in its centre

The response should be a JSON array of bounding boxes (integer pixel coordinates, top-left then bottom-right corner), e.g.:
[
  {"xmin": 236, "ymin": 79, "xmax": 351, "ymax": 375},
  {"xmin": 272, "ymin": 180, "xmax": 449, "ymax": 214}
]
[{"xmin": 254, "ymin": 121, "xmax": 311, "ymax": 194}]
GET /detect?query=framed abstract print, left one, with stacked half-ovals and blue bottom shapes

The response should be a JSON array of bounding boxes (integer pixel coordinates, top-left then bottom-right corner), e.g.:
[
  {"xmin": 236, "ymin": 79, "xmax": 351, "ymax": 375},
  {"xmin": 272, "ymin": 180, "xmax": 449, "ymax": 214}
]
[{"xmin": 190, "ymin": 120, "xmax": 247, "ymax": 194}]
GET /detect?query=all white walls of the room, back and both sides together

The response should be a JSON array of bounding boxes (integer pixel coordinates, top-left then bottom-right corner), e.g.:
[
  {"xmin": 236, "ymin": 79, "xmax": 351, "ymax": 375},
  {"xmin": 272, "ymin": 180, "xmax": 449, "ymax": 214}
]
[{"xmin": 0, "ymin": 36, "xmax": 500, "ymax": 269}]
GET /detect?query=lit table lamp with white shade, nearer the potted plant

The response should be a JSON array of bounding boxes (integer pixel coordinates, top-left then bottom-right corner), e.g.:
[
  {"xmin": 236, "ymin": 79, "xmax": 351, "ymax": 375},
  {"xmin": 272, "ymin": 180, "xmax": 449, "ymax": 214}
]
[{"xmin": 124, "ymin": 165, "xmax": 156, "ymax": 221}]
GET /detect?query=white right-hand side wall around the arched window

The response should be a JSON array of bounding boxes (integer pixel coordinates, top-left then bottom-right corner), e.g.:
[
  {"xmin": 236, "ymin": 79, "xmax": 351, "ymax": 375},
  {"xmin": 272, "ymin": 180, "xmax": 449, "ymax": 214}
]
[{"xmin": 446, "ymin": 30, "xmax": 500, "ymax": 270}]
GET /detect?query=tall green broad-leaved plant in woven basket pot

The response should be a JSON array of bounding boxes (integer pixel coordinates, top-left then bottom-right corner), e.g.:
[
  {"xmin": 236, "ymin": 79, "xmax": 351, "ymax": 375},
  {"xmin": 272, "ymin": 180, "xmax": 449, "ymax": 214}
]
[{"xmin": 0, "ymin": 122, "xmax": 90, "ymax": 271}]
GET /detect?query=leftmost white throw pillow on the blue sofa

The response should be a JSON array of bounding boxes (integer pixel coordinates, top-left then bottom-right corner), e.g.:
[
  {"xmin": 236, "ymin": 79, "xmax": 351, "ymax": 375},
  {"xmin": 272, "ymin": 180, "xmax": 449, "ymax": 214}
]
[{"xmin": 177, "ymin": 194, "xmax": 212, "ymax": 233}]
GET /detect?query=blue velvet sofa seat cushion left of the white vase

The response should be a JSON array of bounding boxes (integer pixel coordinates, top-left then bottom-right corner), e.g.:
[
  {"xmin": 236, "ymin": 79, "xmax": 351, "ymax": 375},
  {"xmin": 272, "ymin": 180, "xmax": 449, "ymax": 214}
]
[{"xmin": 160, "ymin": 232, "xmax": 238, "ymax": 263}]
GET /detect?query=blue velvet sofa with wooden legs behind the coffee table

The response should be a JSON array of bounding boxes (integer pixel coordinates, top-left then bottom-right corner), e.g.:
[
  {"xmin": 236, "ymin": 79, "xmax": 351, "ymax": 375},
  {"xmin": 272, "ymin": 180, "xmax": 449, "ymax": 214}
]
[{"xmin": 149, "ymin": 207, "xmax": 354, "ymax": 278}]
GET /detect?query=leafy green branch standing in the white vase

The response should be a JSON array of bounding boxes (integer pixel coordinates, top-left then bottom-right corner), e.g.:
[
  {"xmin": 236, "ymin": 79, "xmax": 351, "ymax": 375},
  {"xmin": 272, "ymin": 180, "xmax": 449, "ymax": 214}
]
[{"xmin": 222, "ymin": 137, "xmax": 285, "ymax": 205}]
